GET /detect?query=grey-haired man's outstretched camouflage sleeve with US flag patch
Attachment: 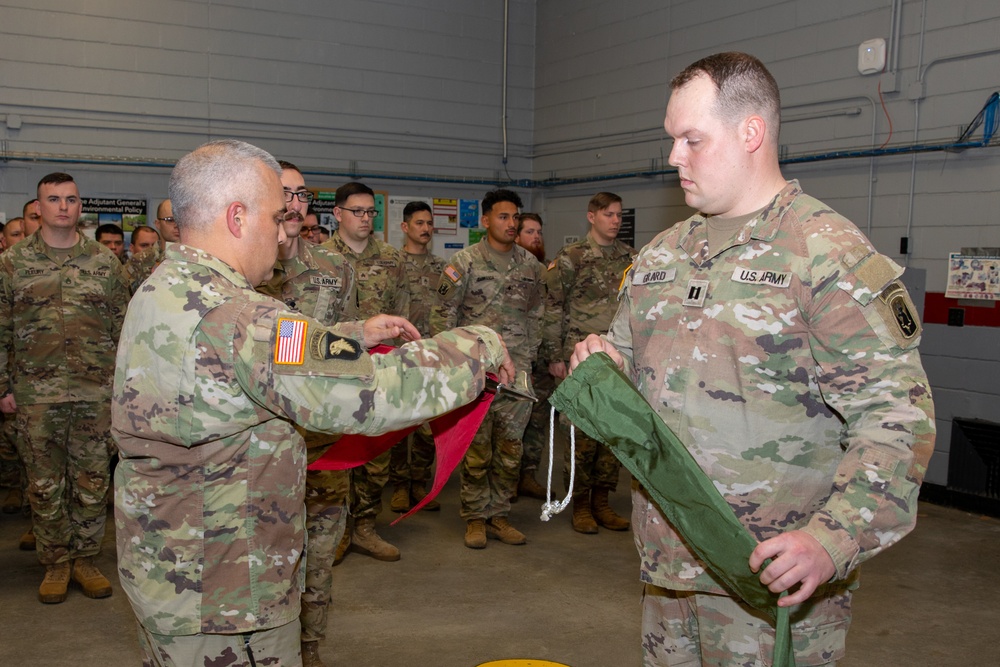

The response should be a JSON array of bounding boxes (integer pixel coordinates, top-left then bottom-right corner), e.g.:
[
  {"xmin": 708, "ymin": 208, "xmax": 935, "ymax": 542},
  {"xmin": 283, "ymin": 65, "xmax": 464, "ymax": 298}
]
[{"xmin": 234, "ymin": 303, "xmax": 503, "ymax": 435}]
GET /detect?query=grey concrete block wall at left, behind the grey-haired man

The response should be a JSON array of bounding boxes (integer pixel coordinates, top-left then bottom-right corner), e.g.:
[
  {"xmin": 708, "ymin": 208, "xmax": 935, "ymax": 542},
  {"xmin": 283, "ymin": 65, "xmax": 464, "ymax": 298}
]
[{"xmin": 0, "ymin": 0, "xmax": 535, "ymax": 216}]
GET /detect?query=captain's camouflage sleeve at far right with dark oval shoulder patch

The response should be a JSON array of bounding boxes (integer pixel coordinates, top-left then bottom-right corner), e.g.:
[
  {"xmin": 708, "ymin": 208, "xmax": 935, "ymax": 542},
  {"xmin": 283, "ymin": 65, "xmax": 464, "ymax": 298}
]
[{"xmin": 804, "ymin": 252, "xmax": 935, "ymax": 578}]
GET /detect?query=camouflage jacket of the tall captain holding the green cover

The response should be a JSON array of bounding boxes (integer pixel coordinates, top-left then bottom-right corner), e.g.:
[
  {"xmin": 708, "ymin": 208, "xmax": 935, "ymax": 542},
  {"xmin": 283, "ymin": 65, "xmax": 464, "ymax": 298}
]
[{"xmin": 608, "ymin": 181, "xmax": 934, "ymax": 593}]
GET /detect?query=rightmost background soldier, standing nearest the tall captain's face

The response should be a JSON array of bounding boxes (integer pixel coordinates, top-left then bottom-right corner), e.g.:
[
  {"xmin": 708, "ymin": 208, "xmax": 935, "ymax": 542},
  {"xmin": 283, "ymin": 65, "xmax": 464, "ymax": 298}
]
[{"xmin": 540, "ymin": 192, "xmax": 635, "ymax": 534}]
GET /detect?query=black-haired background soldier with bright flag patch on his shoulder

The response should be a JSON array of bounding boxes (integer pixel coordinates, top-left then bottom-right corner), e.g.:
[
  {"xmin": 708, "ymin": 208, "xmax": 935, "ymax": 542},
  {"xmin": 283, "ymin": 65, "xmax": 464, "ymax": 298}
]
[{"xmin": 431, "ymin": 190, "xmax": 545, "ymax": 549}]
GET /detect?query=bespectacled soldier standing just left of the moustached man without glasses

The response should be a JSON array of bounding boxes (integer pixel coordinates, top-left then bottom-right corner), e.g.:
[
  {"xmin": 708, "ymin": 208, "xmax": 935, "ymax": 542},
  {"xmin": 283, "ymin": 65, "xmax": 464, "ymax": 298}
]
[{"xmin": 321, "ymin": 182, "xmax": 410, "ymax": 562}]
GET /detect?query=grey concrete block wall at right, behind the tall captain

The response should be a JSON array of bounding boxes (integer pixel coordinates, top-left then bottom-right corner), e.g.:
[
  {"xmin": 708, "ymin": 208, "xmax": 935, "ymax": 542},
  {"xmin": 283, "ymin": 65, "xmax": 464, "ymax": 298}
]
[{"xmin": 533, "ymin": 0, "xmax": 1000, "ymax": 484}]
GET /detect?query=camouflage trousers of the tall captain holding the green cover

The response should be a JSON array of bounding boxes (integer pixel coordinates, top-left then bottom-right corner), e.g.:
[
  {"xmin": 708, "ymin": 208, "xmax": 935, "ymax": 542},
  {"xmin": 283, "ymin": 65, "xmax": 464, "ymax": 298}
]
[{"xmin": 642, "ymin": 584, "xmax": 851, "ymax": 667}]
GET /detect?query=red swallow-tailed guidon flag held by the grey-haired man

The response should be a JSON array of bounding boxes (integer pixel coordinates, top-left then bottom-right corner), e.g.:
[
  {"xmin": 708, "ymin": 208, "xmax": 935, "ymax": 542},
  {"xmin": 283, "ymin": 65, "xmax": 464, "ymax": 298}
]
[{"xmin": 309, "ymin": 345, "xmax": 496, "ymax": 525}]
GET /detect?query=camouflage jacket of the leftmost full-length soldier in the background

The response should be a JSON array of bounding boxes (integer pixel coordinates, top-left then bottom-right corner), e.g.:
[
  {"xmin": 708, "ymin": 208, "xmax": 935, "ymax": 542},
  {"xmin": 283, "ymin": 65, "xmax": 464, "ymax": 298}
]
[{"xmin": 0, "ymin": 233, "xmax": 129, "ymax": 405}]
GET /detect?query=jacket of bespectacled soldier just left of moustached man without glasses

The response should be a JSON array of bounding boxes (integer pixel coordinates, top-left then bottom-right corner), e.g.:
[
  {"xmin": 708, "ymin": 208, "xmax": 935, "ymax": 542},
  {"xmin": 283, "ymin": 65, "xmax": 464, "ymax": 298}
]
[{"xmin": 320, "ymin": 232, "xmax": 410, "ymax": 319}]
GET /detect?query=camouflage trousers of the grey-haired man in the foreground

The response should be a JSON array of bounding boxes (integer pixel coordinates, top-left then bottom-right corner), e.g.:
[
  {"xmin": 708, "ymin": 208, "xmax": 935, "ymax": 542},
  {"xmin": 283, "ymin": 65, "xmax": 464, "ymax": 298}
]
[{"xmin": 139, "ymin": 620, "xmax": 302, "ymax": 667}]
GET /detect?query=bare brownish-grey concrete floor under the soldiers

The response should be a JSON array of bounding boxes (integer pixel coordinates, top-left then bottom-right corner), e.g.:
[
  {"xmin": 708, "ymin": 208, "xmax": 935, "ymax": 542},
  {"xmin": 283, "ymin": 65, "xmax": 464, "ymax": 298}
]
[{"xmin": 0, "ymin": 468, "xmax": 1000, "ymax": 667}]
